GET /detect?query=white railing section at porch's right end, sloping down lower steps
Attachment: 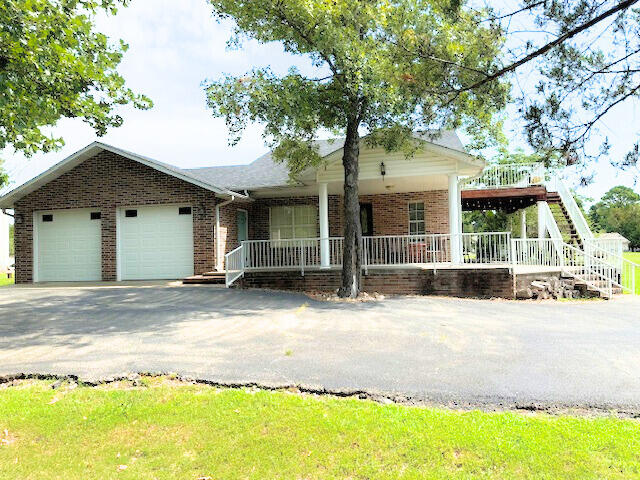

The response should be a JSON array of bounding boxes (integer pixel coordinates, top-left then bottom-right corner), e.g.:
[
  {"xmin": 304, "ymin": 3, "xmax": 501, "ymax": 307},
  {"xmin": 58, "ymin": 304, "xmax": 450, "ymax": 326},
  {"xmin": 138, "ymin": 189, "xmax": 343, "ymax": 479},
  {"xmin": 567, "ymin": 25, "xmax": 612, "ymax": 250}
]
[{"xmin": 511, "ymin": 238, "xmax": 622, "ymax": 298}]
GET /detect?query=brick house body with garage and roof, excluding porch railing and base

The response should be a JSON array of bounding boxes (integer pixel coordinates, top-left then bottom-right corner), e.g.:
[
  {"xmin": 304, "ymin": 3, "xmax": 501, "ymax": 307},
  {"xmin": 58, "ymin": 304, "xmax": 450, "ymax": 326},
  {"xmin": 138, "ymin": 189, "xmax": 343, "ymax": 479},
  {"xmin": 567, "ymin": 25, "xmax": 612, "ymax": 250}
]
[{"xmin": 0, "ymin": 132, "xmax": 484, "ymax": 283}]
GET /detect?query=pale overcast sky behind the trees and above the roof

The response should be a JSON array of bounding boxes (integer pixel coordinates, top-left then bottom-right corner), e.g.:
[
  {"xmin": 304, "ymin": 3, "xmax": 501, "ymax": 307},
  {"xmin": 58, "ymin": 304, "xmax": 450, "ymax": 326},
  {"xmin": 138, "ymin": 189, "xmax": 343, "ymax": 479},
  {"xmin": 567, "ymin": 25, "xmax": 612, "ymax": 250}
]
[{"xmin": 2, "ymin": 0, "xmax": 640, "ymax": 202}]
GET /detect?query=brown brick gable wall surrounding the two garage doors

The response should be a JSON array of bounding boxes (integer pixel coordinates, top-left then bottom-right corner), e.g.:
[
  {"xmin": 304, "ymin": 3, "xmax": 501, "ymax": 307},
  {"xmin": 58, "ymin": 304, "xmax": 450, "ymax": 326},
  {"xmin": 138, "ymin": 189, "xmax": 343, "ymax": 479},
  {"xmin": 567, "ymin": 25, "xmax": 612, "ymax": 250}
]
[{"xmin": 15, "ymin": 152, "xmax": 216, "ymax": 283}]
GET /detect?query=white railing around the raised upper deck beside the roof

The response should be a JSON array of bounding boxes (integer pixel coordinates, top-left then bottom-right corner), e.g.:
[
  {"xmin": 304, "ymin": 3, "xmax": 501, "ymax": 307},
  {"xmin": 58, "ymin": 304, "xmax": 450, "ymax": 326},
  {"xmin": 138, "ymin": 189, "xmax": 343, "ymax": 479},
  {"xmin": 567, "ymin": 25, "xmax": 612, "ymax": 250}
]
[{"xmin": 461, "ymin": 162, "xmax": 545, "ymax": 190}]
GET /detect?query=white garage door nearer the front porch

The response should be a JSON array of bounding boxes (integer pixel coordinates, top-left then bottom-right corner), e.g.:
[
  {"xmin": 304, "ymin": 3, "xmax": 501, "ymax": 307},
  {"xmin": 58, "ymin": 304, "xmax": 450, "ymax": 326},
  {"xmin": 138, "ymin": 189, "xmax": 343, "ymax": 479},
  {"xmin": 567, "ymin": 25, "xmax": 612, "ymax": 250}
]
[{"xmin": 118, "ymin": 205, "xmax": 193, "ymax": 280}]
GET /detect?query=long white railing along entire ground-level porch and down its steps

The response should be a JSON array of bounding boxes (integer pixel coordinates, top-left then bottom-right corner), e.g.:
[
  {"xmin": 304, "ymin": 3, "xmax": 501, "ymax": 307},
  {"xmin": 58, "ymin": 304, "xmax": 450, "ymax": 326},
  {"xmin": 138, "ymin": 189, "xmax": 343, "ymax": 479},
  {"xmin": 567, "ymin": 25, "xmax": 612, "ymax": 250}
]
[{"xmin": 225, "ymin": 232, "xmax": 640, "ymax": 297}]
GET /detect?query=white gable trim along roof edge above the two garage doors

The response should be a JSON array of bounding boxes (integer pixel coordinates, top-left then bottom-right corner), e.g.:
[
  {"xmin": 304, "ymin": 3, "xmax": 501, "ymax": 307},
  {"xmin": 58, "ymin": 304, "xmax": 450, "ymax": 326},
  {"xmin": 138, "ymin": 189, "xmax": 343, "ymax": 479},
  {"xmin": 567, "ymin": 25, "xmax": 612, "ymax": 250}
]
[{"xmin": 0, "ymin": 142, "xmax": 246, "ymax": 208}]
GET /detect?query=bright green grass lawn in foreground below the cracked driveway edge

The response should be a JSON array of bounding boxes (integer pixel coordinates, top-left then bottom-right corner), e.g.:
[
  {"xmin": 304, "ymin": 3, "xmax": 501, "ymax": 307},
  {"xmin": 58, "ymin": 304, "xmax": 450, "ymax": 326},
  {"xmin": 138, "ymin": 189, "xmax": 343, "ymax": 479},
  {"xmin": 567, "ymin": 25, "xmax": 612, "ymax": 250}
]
[{"xmin": 0, "ymin": 378, "xmax": 640, "ymax": 480}]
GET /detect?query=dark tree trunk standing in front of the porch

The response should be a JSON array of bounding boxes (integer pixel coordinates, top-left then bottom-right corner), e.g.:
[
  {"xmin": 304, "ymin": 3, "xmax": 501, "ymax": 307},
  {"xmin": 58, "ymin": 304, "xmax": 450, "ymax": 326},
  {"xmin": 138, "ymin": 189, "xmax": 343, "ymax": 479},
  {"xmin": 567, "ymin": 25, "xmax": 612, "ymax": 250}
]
[{"xmin": 338, "ymin": 120, "xmax": 362, "ymax": 298}]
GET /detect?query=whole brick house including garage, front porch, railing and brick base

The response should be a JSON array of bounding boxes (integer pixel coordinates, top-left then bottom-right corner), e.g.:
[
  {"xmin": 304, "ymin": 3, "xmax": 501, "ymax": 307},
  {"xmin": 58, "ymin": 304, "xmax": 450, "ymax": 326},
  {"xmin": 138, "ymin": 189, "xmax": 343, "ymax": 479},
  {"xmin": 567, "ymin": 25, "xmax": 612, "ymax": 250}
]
[{"xmin": 0, "ymin": 132, "xmax": 615, "ymax": 297}]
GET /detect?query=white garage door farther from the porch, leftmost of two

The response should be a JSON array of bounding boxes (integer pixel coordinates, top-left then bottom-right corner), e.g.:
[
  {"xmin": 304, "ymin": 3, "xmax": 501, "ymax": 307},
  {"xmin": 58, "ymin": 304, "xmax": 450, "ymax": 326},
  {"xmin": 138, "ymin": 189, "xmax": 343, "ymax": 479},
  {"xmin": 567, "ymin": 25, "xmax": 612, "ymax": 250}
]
[{"xmin": 34, "ymin": 210, "xmax": 102, "ymax": 282}]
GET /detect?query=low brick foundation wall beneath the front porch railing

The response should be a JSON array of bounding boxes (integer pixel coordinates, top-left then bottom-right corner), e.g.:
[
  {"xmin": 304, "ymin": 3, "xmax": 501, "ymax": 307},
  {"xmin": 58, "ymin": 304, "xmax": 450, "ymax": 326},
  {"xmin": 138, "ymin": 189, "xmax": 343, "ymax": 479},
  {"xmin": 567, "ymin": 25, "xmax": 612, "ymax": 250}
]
[{"xmin": 240, "ymin": 268, "xmax": 515, "ymax": 298}]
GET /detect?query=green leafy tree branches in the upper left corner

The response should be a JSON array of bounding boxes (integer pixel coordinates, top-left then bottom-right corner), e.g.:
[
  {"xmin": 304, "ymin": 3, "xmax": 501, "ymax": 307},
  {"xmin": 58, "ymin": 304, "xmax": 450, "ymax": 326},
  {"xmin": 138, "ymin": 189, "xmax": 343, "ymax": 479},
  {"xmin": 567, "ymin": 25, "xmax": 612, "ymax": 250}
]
[{"xmin": 0, "ymin": 0, "xmax": 151, "ymax": 156}]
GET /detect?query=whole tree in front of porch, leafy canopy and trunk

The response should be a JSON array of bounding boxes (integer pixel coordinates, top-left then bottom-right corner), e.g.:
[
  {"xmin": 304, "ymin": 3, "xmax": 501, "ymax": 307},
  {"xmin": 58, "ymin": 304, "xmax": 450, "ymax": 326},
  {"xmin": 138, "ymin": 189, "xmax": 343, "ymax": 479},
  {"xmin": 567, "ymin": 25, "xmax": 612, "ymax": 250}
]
[{"xmin": 206, "ymin": 0, "xmax": 508, "ymax": 296}]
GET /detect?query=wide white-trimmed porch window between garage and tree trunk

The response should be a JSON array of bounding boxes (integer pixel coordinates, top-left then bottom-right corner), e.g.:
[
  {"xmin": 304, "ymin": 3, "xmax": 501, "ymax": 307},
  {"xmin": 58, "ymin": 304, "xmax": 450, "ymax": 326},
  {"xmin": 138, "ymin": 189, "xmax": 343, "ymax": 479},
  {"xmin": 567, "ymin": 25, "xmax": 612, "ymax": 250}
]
[{"xmin": 269, "ymin": 205, "xmax": 318, "ymax": 240}]
